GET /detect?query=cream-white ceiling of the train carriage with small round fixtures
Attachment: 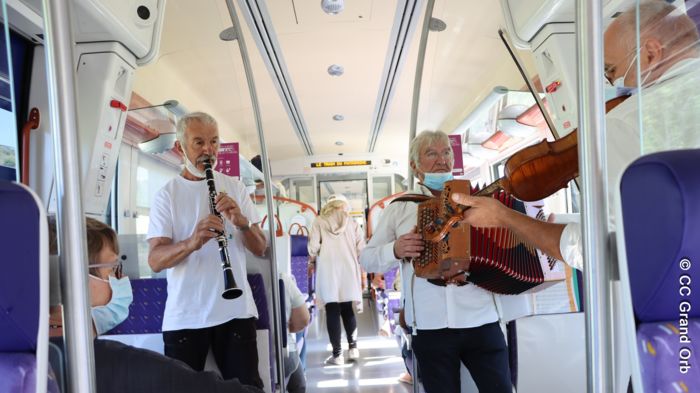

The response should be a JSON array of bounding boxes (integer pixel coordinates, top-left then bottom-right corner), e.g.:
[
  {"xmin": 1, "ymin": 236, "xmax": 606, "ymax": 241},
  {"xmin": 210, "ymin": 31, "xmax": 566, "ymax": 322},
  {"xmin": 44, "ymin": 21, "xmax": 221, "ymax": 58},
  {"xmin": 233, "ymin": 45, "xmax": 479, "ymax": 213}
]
[{"xmin": 134, "ymin": 0, "xmax": 534, "ymax": 170}]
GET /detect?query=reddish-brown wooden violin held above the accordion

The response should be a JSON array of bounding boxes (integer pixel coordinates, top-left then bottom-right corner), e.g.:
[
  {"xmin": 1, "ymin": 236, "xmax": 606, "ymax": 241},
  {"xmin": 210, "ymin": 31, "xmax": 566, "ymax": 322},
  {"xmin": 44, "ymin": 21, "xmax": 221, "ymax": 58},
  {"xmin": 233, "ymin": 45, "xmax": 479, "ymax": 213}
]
[{"xmin": 476, "ymin": 95, "xmax": 630, "ymax": 202}]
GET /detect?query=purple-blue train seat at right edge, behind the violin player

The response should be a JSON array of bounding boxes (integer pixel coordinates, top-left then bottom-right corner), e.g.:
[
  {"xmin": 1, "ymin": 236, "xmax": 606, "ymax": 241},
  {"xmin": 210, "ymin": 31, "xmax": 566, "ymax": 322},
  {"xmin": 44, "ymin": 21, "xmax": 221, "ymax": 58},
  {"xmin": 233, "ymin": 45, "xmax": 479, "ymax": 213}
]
[{"xmin": 617, "ymin": 149, "xmax": 700, "ymax": 392}]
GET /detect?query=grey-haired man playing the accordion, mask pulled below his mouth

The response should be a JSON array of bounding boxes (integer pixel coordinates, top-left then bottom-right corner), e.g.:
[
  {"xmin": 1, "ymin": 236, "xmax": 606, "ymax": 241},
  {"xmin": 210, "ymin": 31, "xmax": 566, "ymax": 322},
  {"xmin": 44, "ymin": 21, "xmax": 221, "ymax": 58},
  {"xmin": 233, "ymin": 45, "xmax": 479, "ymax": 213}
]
[{"xmin": 360, "ymin": 131, "xmax": 512, "ymax": 393}]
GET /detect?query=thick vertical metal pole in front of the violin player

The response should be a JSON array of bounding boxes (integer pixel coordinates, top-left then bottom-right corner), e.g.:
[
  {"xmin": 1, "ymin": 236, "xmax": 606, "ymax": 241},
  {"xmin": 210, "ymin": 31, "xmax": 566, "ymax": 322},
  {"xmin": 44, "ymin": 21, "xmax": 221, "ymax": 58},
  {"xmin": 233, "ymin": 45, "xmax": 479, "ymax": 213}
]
[{"xmin": 576, "ymin": 0, "xmax": 613, "ymax": 393}]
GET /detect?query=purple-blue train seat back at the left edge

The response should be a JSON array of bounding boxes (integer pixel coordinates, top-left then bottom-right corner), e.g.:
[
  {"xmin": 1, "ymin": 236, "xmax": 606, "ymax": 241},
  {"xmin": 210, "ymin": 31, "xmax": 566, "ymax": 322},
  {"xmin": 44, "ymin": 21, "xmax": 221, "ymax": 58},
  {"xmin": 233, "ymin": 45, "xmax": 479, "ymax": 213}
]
[{"xmin": 0, "ymin": 181, "xmax": 58, "ymax": 392}]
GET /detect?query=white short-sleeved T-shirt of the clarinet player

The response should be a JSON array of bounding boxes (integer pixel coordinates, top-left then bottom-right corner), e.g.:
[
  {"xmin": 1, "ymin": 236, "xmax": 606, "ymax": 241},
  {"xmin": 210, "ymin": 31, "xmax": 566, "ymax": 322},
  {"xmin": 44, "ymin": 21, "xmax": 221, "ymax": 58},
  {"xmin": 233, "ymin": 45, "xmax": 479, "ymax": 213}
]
[{"xmin": 147, "ymin": 172, "xmax": 260, "ymax": 331}]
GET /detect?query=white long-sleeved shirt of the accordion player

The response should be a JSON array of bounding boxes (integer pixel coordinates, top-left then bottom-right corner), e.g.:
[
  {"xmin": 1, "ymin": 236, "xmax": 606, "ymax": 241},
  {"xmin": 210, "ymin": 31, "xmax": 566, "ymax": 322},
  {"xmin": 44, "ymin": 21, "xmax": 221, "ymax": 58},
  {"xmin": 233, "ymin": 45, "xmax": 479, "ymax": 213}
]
[{"xmin": 360, "ymin": 185, "xmax": 498, "ymax": 330}]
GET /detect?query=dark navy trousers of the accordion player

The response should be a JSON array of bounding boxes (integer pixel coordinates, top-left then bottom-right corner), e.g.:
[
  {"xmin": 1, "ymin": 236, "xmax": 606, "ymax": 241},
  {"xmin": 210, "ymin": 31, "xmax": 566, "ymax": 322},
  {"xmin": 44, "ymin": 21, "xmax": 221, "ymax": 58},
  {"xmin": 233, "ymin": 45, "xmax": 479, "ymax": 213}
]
[{"xmin": 413, "ymin": 322, "xmax": 513, "ymax": 393}]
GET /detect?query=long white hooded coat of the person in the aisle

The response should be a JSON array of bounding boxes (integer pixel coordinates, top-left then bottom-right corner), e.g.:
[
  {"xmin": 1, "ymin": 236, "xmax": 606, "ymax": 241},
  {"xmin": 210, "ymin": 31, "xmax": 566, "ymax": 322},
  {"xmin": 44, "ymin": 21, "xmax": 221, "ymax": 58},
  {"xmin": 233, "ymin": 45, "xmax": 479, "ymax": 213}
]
[{"xmin": 308, "ymin": 210, "xmax": 365, "ymax": 303}]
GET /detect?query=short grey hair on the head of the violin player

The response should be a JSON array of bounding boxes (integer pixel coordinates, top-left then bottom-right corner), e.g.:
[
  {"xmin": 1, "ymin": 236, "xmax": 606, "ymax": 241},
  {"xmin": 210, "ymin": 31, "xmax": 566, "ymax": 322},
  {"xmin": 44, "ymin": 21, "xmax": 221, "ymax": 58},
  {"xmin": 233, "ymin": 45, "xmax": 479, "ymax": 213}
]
[{"xmin": 614, "ymin": 0, "xmax": 698, "ymax": 54}]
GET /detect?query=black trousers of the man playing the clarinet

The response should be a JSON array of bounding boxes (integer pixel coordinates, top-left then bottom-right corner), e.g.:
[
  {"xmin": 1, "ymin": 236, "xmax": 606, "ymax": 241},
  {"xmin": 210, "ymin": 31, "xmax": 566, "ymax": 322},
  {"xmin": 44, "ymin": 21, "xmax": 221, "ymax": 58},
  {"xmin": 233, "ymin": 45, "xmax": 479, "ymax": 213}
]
[{"xmin": 163, "ymin": 318, "xmax": 263, "ymax": 388}]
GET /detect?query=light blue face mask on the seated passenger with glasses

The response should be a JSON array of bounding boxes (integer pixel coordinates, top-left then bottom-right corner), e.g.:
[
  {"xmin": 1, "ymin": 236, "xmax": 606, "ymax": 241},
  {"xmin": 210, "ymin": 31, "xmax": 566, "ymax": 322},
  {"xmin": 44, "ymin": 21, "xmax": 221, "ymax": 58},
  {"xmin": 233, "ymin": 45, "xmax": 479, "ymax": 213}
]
[{"xmin": 91, "ymin": 276, "xmax": 134, "ymax": 336}]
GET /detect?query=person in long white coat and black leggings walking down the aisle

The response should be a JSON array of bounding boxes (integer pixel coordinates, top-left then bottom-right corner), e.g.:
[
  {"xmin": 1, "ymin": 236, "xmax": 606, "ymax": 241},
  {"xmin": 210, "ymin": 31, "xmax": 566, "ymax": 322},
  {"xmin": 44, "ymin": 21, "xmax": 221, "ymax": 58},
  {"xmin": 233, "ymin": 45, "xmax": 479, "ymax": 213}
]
[{"xmin": 308, "ymin": 194, "xmax": 365, "ymax": 364}]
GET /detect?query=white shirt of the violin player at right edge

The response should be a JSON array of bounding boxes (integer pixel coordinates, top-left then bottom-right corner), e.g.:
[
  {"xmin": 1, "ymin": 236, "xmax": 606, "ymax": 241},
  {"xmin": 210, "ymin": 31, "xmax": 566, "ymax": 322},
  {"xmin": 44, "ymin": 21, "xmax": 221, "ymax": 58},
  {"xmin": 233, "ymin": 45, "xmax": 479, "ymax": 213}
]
[{"xmin": 559, "ymin": 59, "xmax": 700, "ymax": 269}]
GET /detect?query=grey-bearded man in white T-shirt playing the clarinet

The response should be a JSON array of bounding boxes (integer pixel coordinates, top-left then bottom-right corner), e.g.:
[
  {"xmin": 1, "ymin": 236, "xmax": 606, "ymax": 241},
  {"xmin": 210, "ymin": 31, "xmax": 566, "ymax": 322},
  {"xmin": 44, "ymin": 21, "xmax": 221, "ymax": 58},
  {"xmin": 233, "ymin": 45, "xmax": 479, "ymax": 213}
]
[{"xmin": 147, "ymin": 112, "xmax": 266, "ymax": 388}]
